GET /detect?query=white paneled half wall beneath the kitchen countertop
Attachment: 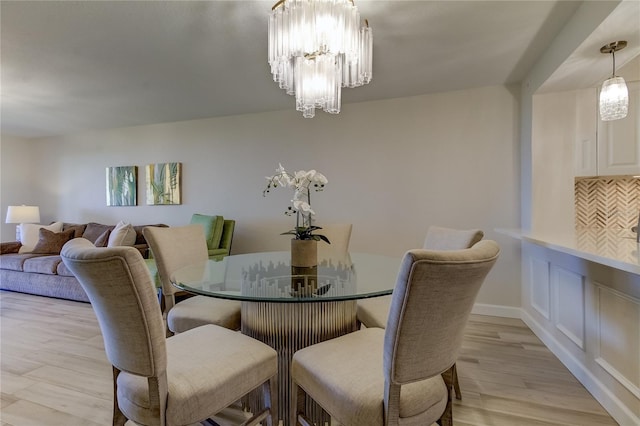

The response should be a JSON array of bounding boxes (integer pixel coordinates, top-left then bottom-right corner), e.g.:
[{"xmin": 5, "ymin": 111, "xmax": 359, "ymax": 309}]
[{"xmin": 522, "ymin": 242, "xmax": 640, "ymax": 425}]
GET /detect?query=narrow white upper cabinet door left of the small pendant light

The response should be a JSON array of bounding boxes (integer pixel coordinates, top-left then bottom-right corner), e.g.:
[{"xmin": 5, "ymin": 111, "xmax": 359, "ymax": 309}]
[{"xmin": 574, "ymin": 88, "xmax": 598, "ymax": 176}]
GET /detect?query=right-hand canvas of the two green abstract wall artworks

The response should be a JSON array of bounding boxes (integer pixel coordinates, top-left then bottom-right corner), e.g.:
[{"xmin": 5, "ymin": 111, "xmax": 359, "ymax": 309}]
[{"xmin": 147, "ymin": 163, "xmax": 182, "ymax": 206}]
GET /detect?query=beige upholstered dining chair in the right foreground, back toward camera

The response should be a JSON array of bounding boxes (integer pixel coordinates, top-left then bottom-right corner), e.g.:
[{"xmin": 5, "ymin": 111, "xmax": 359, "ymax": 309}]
[{"xmin": 291, "ymin": 240, "xmax": 500, "ymax": 426}]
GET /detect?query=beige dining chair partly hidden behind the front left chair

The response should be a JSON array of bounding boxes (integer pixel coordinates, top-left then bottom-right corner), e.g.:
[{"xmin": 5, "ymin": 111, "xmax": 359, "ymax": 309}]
[{"xmin": 142, "ymin": 224, "xmax": 241, "ymax": 335}]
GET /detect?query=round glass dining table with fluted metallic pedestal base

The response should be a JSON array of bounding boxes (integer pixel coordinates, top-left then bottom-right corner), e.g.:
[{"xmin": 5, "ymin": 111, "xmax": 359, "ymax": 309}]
[{"xmin": 172, "ymin": 251, "xmax": 400, "ymax": 426}]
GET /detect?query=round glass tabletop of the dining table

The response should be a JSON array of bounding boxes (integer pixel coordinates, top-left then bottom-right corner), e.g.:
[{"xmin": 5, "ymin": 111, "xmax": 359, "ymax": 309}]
[{"xmin": 172, "ymin": 251, "xmax": 400, "ymax": 303}]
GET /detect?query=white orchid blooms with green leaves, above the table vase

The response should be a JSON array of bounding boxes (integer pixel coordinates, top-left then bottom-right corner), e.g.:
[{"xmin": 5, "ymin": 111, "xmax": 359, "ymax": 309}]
[{"xmin": 262, "ymin": 164, "xmax": 331, "ymax": 244}]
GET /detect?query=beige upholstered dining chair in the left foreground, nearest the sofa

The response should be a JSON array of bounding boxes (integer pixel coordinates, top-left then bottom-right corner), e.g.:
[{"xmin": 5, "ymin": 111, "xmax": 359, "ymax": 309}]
[{"xmin": 61, "ymin": 238, "xmax": 278, "ymax": 426}]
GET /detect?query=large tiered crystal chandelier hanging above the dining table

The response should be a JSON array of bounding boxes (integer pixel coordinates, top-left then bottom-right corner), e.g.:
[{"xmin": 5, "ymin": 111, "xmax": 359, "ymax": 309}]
[{"xmin": 269, "ymin": 0, "xmax": 373, "ymax": 118}]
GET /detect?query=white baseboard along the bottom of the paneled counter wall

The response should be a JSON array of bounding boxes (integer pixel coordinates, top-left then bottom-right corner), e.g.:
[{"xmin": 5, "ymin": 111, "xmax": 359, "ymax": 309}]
[{"xmin": 521, "ymin": 309, "xmax": 640, "ymax": 426}]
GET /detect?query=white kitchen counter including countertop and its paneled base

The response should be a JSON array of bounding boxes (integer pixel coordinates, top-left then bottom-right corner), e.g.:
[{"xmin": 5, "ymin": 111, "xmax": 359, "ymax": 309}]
[{"xmin": 496, "ymin": 229, "xmax": 640, "ymax": 425}]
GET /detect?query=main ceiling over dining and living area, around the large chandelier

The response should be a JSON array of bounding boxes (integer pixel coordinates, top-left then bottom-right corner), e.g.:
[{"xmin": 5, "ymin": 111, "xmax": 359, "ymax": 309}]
[{"xmin": 0, "ymin": 0, "xmax": 636, "ymax": 138}]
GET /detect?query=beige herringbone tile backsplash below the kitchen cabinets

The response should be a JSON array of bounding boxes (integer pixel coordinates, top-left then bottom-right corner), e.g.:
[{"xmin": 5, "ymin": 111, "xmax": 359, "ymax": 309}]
[{"xmin": 575, "ymin": 177, "xmax": 640, "ymax": 229}]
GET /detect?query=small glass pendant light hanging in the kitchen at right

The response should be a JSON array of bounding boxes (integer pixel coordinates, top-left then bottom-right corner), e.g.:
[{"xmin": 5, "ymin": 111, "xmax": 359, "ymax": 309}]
[{"xmin": 600, "ymin": 40, "xmax": 629, "ymax": 121}]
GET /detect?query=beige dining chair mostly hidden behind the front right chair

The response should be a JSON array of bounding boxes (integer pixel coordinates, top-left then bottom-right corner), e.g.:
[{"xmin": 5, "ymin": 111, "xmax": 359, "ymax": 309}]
[{"xmin": 357, "ymin": 226, "xmax": 484, "ymax": 399}]
